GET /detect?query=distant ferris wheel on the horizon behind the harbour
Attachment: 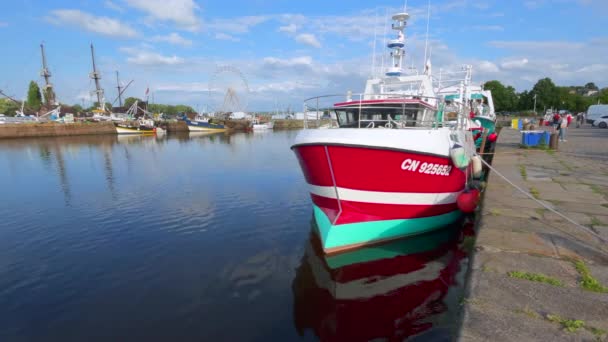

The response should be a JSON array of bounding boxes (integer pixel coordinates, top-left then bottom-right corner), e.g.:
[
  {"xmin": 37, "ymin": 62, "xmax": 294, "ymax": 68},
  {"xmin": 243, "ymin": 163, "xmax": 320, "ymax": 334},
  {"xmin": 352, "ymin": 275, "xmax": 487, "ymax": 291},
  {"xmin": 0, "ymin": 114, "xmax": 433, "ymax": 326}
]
[{"xmin": 209, "ymin": 65, "xmax": 249, "ymax": 115}]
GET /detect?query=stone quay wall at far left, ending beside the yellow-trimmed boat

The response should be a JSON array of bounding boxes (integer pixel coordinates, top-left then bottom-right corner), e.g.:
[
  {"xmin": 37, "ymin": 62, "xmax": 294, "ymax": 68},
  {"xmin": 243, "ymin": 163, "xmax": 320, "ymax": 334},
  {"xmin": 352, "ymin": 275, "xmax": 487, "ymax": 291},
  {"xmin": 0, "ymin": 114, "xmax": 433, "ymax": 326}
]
[{"xmin": 0, "ymin": 122, "xmax": 116, "ymax": 139}]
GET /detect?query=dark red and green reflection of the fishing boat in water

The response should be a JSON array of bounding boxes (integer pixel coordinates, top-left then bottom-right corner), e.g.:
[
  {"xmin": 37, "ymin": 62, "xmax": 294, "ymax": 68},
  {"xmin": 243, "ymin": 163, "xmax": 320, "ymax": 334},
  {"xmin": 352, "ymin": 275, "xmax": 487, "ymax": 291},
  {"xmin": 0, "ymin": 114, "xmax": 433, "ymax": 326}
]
[{"xmin": 292, "ymin": 220, "xmax": 473, "ymax": 341}]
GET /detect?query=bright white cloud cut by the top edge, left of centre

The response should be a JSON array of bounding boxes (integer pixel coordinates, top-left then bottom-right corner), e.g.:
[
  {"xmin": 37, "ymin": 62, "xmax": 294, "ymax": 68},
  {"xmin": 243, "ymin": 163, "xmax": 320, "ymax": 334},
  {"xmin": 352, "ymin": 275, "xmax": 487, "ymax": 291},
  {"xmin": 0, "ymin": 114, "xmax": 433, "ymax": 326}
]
[{"xmin": 126, "ymin": 0, "xmax": 201, "ymax": 31}]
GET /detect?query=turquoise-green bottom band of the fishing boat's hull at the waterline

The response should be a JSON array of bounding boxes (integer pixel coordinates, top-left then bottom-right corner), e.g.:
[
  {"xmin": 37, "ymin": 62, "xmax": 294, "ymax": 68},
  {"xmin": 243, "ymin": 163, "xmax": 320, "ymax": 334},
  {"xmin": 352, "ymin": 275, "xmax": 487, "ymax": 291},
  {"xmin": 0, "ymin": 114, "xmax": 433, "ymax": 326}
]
[{"xmin": 313, "ymin": 205, "xmax": 462, "ymax": 249}]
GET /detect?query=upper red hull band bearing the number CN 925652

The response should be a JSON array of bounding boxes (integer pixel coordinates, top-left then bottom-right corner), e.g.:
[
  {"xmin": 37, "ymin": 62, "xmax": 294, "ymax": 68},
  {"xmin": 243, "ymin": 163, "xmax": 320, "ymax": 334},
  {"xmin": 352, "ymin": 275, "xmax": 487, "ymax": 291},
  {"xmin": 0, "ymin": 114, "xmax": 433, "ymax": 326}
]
[{"xmin": 294, "ymin": 145, "xmax": 465, "ymax": 193}]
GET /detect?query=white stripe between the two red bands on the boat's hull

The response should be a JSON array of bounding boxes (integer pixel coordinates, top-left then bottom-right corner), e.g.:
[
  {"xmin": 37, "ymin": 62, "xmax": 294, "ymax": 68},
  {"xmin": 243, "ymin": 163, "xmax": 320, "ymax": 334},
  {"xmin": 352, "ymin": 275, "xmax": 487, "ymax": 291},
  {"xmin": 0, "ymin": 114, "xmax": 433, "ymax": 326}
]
[{"xmin": 309, "ymin": 184, "xmax": 460, "ymax": 205}]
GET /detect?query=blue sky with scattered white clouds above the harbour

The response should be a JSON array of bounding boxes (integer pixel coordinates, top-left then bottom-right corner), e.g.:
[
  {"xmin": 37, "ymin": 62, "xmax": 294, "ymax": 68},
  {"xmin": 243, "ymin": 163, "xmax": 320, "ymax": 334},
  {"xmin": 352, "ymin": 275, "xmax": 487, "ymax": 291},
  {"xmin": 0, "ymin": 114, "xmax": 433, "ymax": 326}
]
[{"xmin": 0, "ymin": 0, "xmax": 608, "ymax": 110}]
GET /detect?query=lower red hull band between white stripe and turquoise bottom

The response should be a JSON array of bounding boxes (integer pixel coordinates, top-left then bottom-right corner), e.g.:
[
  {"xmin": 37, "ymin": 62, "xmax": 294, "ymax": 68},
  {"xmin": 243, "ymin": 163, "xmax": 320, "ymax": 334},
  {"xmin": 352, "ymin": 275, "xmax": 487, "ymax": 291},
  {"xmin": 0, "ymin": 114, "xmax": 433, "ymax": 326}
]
[{"xmin": 310, "ymin": 194, "xmax": 458, "ymax": 224}]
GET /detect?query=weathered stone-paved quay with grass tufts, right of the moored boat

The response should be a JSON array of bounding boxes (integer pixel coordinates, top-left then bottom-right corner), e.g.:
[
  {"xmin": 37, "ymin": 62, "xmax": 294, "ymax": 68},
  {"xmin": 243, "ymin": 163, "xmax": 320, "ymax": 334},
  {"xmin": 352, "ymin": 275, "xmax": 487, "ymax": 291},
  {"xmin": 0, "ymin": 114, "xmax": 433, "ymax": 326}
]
[{"xmin": 459, "ymin": 127, "xmax": 608, "ymax": 341}]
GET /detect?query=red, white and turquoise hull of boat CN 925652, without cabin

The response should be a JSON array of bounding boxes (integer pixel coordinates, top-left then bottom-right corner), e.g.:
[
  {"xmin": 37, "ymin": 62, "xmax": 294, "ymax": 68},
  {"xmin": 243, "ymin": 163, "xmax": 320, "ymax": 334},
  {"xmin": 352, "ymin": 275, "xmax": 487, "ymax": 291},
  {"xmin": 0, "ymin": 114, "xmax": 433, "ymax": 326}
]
[{"xmin": 292, "ymin": 129, "xmax": 473, "ymax": 253}]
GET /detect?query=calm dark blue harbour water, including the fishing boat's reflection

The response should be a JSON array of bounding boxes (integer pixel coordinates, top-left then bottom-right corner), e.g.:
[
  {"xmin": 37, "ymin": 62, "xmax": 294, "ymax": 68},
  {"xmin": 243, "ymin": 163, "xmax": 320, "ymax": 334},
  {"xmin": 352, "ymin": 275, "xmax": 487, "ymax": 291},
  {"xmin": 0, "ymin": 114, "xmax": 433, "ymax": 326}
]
[{"xmin": 0, "ymin": 131, "xmax": 467, "ymax": 341}]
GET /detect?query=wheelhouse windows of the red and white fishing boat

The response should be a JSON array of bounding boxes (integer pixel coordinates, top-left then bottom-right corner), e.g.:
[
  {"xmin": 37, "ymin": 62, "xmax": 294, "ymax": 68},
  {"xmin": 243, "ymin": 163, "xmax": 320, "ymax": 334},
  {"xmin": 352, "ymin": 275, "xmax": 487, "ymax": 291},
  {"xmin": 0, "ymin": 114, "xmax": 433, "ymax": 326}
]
[{"xmin": 334, "ymin": 106, "xmax": 422, "ymax": 128}]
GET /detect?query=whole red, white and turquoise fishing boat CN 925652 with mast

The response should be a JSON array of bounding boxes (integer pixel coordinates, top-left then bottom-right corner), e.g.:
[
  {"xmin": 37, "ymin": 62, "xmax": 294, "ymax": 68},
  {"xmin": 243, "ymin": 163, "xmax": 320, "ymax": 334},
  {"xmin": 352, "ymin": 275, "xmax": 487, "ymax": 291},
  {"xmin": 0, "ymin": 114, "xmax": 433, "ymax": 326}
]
[{"xmin": 291, "ymin": 13, "xmax": 475, "ymax": 253}]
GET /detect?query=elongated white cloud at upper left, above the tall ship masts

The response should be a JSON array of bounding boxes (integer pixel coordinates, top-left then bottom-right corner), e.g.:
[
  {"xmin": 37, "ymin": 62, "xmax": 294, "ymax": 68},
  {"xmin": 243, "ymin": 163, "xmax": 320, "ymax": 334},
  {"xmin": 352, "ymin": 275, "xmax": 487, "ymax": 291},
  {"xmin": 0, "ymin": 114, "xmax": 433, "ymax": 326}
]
[{"xmin": 46, "ymin": 9, "xmax": 139, "ymax": 38}]
